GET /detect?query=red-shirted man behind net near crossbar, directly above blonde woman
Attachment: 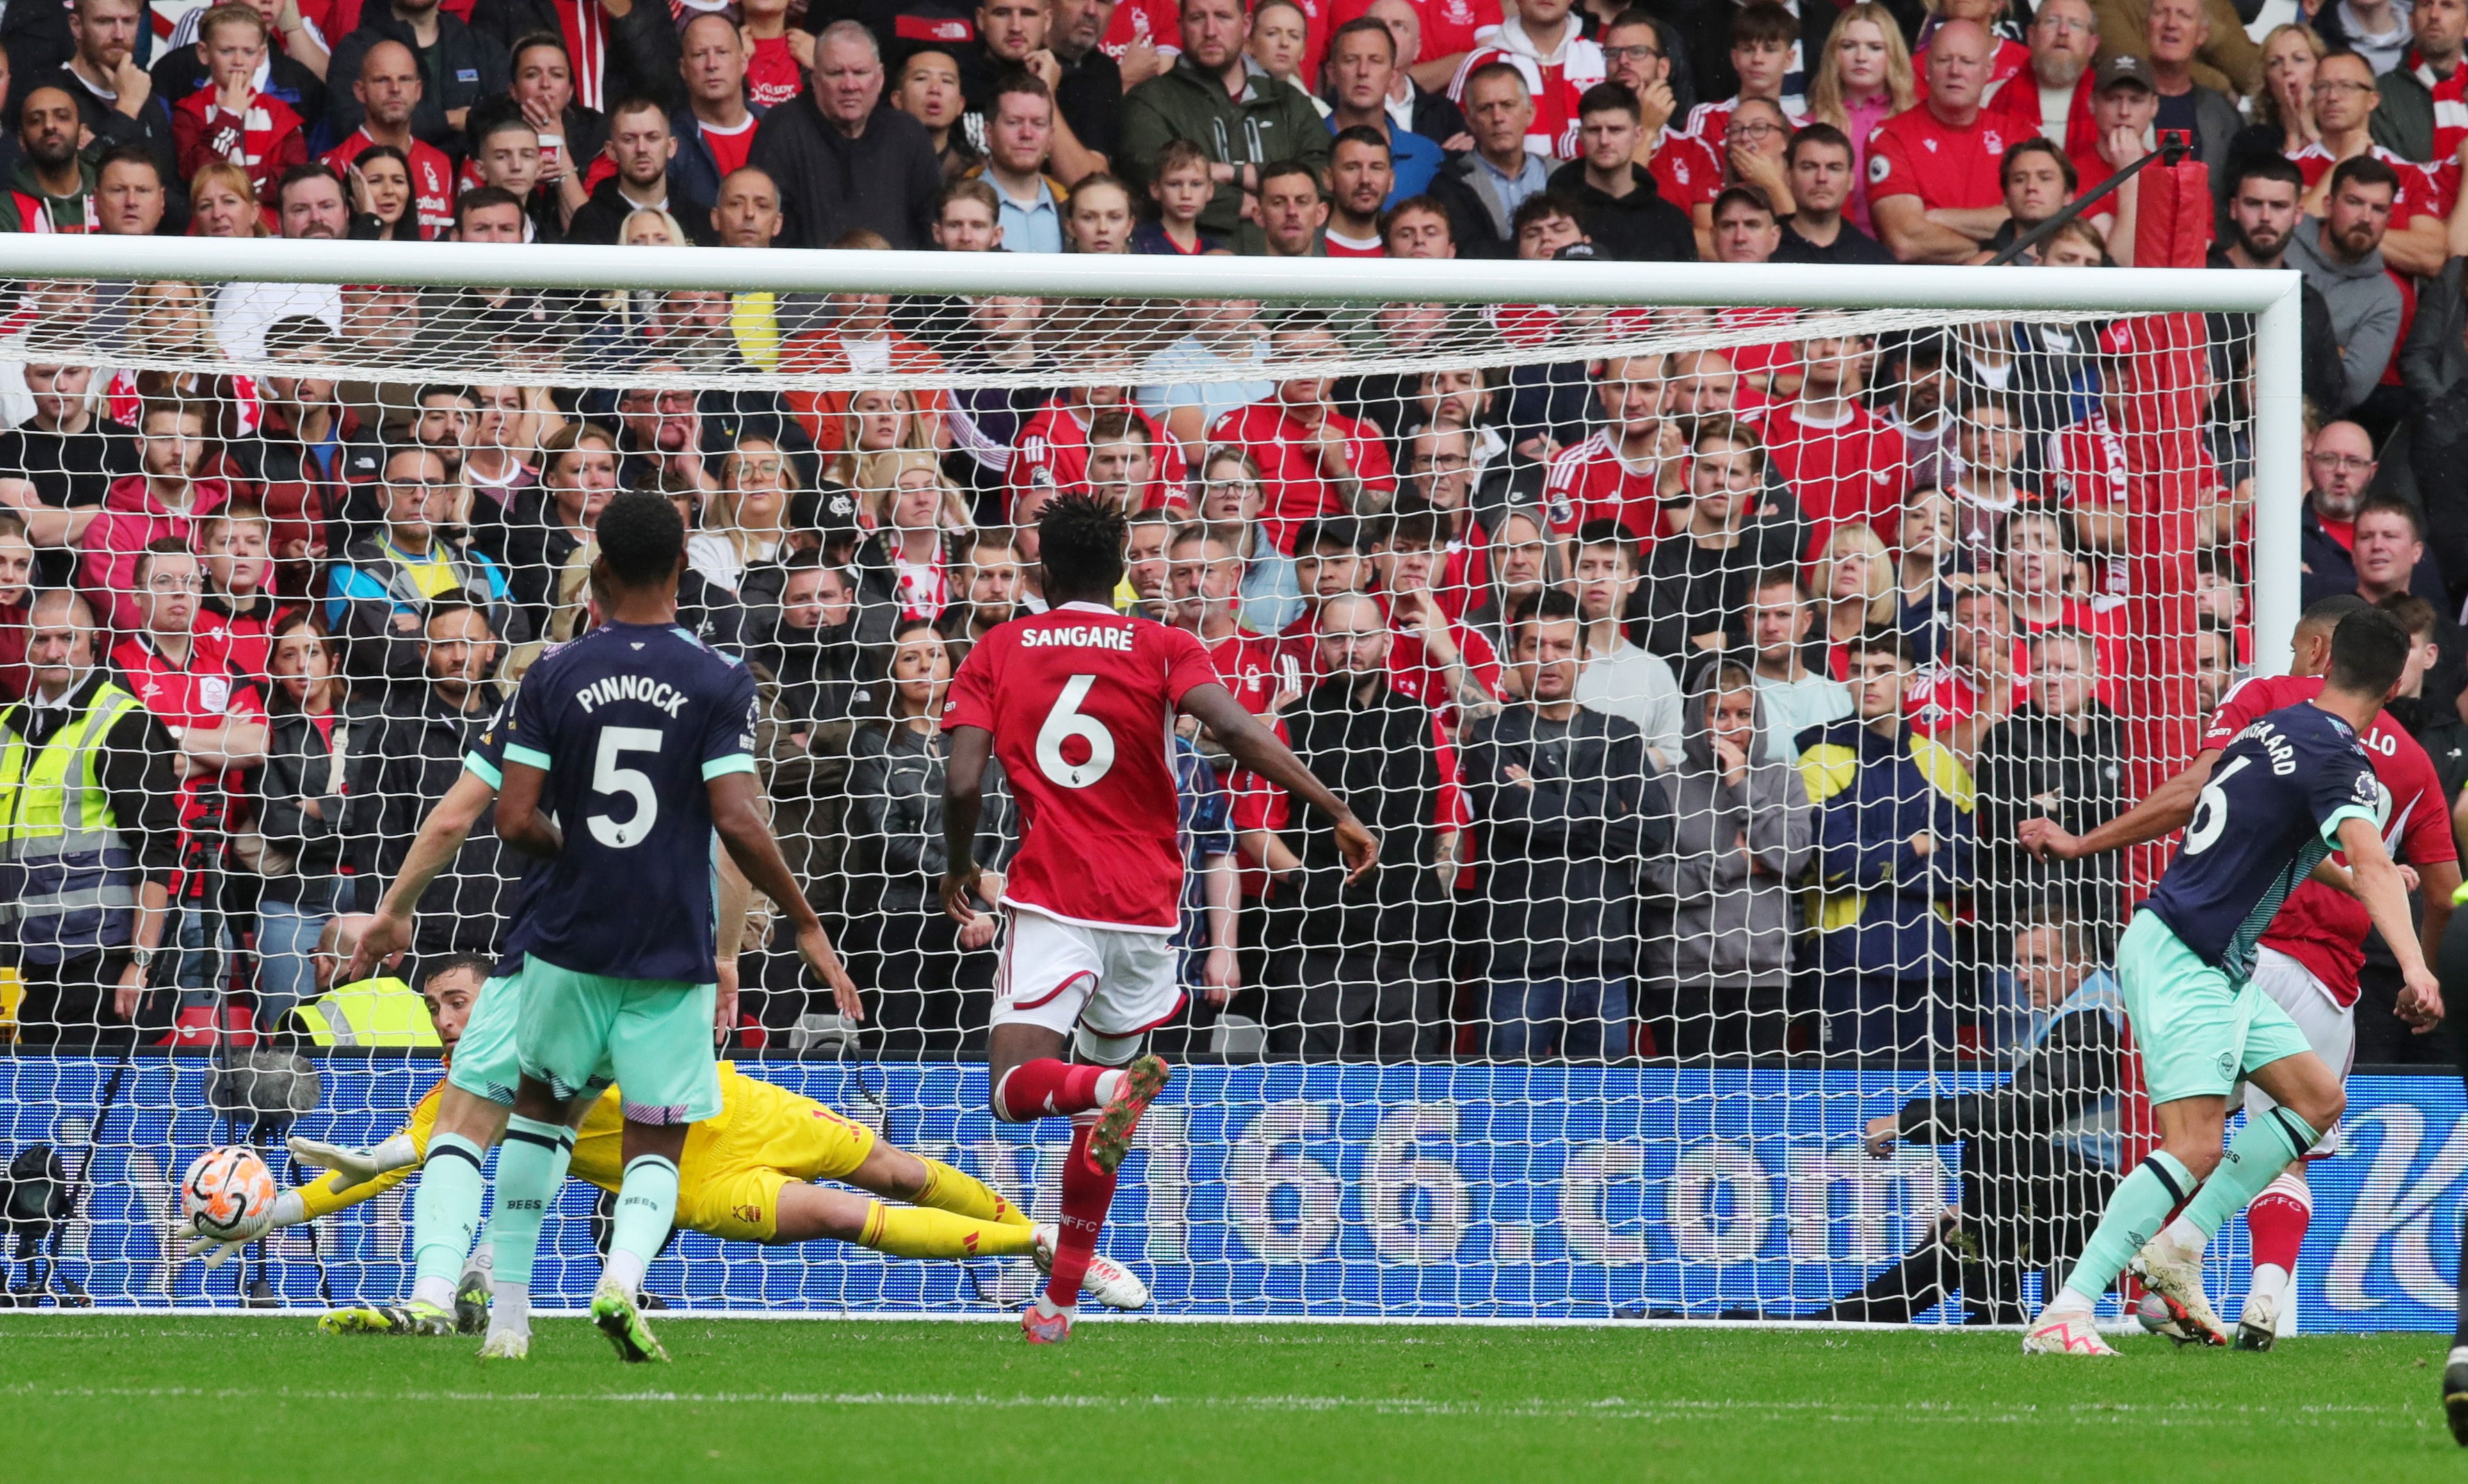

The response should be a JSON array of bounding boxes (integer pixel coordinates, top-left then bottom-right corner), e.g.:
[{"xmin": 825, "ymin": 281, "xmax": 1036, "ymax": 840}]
[{"xmin": 1757, "ymin": 321, "xmax": 1910, "ymax": 551}]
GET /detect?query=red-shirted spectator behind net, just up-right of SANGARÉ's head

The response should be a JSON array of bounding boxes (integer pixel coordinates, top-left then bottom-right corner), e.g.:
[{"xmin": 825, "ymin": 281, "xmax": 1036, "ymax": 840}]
[{"xmin": 1209, "ymin": 316, "xmax": 1397, "ymax": 553}]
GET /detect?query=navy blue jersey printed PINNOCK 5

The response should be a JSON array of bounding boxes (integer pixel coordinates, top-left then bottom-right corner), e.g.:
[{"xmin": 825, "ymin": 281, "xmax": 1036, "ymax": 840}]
[{"xmin": 506, "ymin": 624, "xmax": 755, "ymax": 983}]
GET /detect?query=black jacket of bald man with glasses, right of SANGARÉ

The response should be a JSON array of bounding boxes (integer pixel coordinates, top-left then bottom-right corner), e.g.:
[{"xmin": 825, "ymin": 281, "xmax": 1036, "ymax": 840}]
[{"xmin": 1271, "ymin": 674, "xmax": 1442, "ymax": 953}]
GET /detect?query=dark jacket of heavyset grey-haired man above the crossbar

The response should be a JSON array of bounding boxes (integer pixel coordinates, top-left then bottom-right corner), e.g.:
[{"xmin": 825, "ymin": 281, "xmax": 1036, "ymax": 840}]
[{"xmin": 748, "ymin": 89, "xmax": 943, "ymax": 250}]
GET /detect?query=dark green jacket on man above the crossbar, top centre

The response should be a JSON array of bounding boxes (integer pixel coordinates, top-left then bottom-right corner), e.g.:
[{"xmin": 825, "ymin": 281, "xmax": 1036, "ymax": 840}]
[{"xmin": 1113, "ymin": 52, "xmax": 1330, "ymax": 252}]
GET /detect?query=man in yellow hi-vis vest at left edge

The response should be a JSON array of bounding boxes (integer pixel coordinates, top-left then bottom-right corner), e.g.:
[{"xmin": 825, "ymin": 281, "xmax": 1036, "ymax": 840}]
[{"xmin": 0, "ymin": 592, "xmax": 180, "ymax": 1049}]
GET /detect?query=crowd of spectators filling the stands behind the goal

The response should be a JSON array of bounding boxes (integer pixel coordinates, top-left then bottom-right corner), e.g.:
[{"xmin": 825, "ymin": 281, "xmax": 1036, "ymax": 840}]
[{"xmin": 0, "ymin": 0, "xmax": 2468, "ymax": 1059}]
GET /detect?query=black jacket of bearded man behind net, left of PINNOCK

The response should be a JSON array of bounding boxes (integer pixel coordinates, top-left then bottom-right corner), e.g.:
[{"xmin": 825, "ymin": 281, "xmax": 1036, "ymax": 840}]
[{"xmin": 343, "ymin": 684, "xmax": 523, "ymax": 953}]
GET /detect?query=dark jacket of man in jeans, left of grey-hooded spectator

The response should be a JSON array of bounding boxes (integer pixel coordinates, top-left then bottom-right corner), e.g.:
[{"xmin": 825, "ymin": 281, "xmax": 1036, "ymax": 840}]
[{"xmin": 1458, "ymin": 707, "xmax": 1671, "ymax": 981}]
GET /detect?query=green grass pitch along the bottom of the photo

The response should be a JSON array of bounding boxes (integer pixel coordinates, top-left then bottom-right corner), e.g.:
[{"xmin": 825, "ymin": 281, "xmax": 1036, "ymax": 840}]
[{"xmin": 0, "ymin": 1314, "xmax": 2468, "ymax": 1484}]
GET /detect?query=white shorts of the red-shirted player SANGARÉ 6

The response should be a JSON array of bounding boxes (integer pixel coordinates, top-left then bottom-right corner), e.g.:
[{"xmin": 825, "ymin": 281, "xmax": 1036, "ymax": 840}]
[{"xmin": 994, "ymin": 901, "xmax": 1182, "ymax": 1040}]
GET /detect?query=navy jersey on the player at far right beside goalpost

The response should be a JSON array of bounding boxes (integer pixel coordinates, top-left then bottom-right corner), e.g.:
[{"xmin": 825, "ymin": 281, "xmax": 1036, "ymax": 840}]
[{"xmin": 2145, "ymin": 704, "xmax": 2382, "ymax": 981}]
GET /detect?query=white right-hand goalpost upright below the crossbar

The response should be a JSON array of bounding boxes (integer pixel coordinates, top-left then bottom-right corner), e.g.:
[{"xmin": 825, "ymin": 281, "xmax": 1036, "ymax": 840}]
[{"xmin": 2253, "ymin": 274, "xmax": 2305, "ymax": 674}]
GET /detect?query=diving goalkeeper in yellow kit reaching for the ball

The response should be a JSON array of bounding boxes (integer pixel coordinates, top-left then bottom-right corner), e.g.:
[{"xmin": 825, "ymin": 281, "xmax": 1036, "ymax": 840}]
[{"xmin": 190, "ymin": 955, "xmax": 1147, "ymax": 1333}]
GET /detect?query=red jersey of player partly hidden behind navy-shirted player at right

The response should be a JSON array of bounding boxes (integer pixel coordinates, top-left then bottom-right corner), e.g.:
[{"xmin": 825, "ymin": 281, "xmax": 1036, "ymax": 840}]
[{"xmin": 2202, "ymin": 674, "xmax": 2458, "ymax": 1005}]
